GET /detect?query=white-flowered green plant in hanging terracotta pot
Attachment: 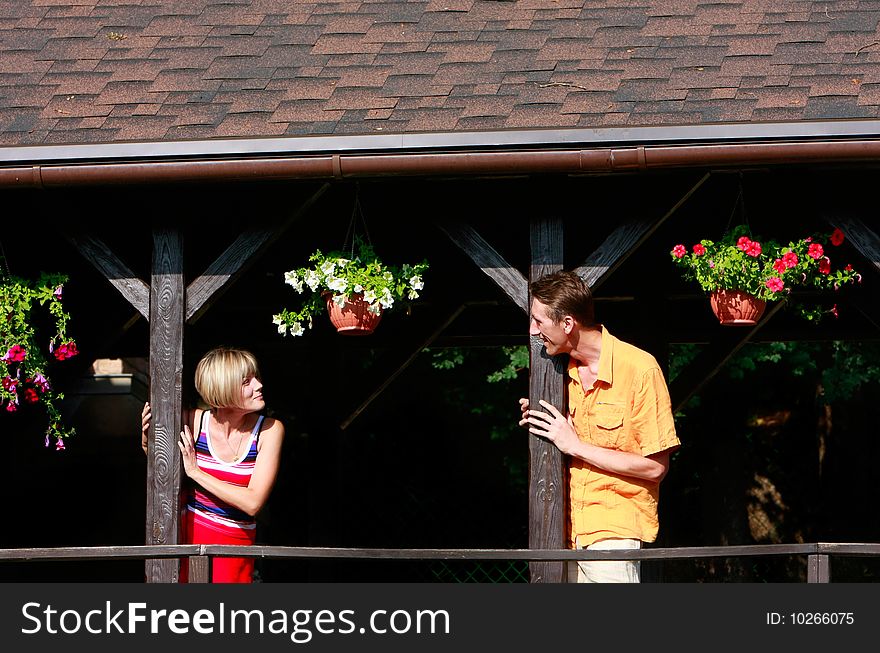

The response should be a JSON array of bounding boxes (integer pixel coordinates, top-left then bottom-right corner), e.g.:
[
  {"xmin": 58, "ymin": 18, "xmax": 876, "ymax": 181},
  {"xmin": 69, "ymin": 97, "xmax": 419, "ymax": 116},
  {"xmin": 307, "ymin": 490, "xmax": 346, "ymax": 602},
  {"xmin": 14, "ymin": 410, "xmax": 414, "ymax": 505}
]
[{"xmin": 272, "ymin": 236, "xmax": 428, "ymax": 336}]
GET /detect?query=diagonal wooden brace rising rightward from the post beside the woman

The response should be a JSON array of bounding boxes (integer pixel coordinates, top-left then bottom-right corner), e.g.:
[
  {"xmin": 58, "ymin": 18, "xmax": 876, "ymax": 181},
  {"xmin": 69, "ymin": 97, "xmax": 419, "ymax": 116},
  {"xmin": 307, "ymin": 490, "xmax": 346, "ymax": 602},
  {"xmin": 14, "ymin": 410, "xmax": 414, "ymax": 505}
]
[{"xmin": 186, "ymin": 183, "xmax": 330, "ymax": 324}]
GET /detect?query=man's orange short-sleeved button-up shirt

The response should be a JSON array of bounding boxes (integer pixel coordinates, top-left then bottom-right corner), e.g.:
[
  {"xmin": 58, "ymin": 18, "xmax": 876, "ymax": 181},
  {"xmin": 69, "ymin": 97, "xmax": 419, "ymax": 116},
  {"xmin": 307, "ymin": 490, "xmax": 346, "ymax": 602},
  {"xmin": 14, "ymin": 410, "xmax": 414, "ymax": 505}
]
[{"xmin": 568, "ymin": 326, "xmax": 681, "ymax": 546}]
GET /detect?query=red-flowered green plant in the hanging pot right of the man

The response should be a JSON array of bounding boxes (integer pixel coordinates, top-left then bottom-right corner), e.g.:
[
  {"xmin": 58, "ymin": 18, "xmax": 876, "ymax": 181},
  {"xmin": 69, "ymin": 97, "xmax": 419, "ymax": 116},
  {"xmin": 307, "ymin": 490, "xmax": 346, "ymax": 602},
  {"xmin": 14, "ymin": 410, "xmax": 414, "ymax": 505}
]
[{"xmin": 670, "ymin": 225, "xmax": 862, "ymax": 320}]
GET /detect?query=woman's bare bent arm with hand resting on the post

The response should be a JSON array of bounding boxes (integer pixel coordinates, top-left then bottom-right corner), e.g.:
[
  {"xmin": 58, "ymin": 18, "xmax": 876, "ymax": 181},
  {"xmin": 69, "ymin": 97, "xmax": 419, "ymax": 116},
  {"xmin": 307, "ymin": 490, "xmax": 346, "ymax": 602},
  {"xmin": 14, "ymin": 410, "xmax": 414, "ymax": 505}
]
[{"xmin": 177, "ymin": 418, "xmax": 284, "ymax": 517}]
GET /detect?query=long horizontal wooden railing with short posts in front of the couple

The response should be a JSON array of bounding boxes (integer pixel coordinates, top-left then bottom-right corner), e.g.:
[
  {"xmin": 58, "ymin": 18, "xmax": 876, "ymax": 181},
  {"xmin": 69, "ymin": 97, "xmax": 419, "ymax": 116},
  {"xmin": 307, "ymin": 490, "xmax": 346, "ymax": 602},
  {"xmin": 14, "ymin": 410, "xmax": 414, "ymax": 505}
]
[{"xmin": 0, "ymin": 542, "xmax": 880, "ymax": 583}]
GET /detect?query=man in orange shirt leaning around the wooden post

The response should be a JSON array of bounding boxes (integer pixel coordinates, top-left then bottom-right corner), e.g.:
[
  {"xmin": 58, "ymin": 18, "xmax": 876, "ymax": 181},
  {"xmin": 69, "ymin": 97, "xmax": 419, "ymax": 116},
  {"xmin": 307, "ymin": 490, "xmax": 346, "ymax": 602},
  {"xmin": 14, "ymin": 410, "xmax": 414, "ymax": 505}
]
[{"xmin": 520, "ymin": 271, "xmax": 681, "ymax": 583}]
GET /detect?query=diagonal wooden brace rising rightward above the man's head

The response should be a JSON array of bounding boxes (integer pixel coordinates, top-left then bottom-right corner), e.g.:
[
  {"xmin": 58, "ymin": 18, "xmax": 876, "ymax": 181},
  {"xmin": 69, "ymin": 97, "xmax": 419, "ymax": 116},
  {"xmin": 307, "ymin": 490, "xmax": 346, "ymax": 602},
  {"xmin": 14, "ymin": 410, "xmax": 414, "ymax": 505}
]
[{"xmin": 575, "ymin": 172, "xmax": 711, "ymax": 290}]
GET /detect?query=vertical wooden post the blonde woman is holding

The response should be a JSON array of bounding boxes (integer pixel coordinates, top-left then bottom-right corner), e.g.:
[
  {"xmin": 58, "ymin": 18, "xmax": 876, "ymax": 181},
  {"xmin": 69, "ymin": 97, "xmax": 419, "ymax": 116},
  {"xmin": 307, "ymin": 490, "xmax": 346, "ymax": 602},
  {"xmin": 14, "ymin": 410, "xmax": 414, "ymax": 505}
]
[{"xmin": 146, "ymin": 228, "xmax": 185, "ymax": 583}]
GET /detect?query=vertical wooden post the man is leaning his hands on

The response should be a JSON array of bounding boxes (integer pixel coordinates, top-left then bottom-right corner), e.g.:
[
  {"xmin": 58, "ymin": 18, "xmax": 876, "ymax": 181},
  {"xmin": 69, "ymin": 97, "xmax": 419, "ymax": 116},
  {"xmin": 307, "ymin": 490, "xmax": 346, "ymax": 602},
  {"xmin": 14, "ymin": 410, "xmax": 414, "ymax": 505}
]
[{"xmin": 529, "ymin": 218, "xmax": 568, "ymax": 583}]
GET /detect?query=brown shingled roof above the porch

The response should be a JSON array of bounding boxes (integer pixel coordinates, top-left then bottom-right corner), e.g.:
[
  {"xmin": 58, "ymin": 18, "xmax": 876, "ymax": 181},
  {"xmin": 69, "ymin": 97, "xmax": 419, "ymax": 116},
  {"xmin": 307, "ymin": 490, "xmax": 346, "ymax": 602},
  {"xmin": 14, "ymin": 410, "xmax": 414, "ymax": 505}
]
[{"xmin": 0, "ymin": 0, "xmax": 880, "ymax": 146}]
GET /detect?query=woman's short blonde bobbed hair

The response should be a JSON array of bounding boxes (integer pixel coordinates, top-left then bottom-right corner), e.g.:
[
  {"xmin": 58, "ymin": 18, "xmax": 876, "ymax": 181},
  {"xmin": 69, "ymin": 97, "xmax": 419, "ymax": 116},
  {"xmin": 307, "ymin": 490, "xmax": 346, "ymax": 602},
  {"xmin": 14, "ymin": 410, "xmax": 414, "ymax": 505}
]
[{"xmin": 195, "ymin": 347, "xmax": 260, "ymax": 408}]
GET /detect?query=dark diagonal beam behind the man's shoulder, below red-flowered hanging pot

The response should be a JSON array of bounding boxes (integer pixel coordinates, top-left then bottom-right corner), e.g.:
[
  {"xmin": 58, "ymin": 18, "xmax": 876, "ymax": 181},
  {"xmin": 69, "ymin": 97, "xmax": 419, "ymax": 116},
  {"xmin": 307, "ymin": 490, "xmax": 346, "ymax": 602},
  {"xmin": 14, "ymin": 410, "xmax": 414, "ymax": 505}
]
[{"xmin": 669, "ymin": 298, "xmax": 785, "ymax": 411}]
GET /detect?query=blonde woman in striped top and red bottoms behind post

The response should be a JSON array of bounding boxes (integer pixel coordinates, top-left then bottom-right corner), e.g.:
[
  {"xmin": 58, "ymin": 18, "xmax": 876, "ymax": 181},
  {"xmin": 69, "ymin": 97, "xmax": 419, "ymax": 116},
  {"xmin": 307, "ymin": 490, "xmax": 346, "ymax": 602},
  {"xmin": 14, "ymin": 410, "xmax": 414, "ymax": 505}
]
[{"xmin": 142, "ymin": 347, "xmax": 284, "ymax": 583}]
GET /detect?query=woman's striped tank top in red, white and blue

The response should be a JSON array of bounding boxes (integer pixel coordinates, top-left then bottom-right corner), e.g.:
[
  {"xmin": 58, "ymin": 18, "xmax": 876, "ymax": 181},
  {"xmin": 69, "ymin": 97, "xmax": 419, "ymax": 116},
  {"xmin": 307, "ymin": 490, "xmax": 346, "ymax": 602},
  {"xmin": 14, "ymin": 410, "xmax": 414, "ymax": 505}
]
[{"xmin": 186, "ymin": 411, "xmax": 263, "ymax": 532}]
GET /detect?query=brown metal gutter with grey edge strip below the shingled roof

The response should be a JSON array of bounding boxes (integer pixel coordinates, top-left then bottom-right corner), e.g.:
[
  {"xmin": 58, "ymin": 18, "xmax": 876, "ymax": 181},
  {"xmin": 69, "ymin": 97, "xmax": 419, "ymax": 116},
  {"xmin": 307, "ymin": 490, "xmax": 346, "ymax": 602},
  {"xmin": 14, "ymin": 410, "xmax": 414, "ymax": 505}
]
[{"xmin": 0, "ymin": 121, "xmax": 880, "ymax": 187}]
